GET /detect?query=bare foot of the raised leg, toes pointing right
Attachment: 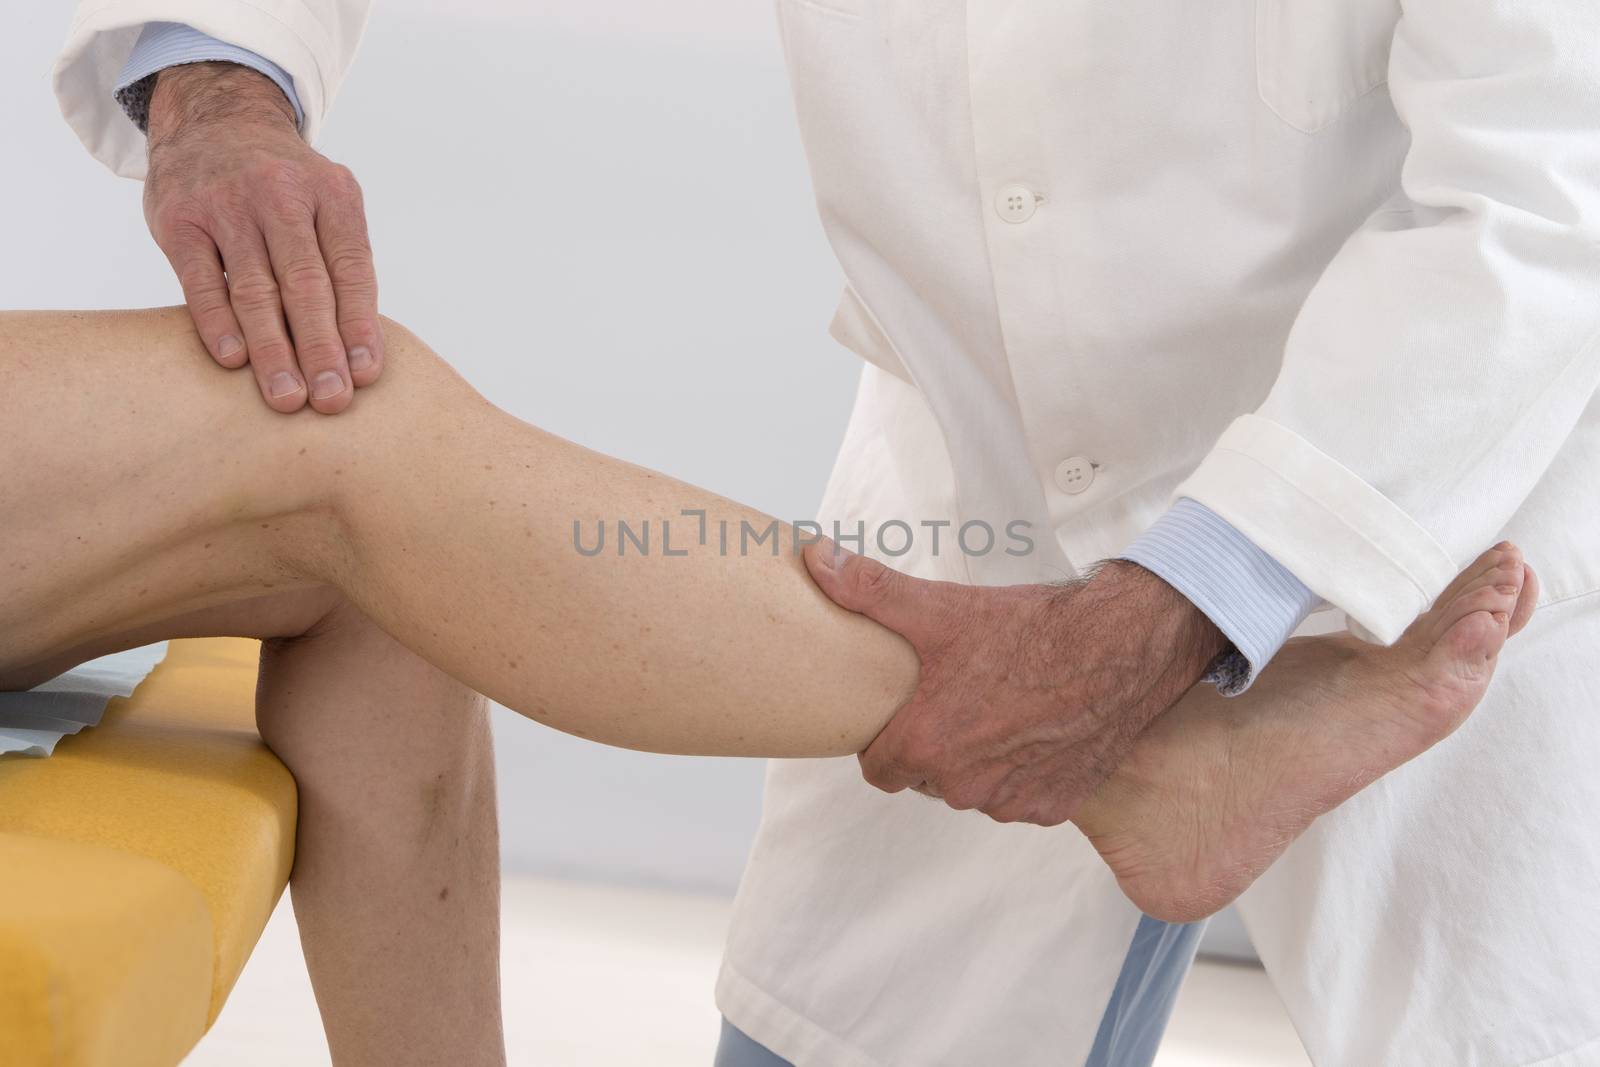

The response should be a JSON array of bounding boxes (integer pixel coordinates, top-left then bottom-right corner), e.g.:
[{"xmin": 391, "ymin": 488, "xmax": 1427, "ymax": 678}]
[{"xmin": 1074, "ymin": 544, "xmax": 1538, "ymax": 923}]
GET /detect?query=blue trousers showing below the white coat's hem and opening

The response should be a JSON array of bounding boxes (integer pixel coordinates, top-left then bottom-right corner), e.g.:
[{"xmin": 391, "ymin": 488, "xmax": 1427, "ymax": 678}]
[{"xmin": 712, "ymin": 917, "xmax": 1205, "ymax": 1067}]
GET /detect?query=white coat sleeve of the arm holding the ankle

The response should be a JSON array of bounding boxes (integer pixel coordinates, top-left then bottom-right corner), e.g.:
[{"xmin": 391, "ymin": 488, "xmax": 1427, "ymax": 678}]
[{"xmin": 1174, "ymin": 0, "xmax": 1600, "ymax": 643}]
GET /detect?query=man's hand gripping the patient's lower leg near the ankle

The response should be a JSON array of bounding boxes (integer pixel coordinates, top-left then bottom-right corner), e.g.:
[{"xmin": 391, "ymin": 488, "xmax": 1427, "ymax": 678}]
[{"xmin": 805, "ymin": 539, "xmax": 1227, "ymax": 825}]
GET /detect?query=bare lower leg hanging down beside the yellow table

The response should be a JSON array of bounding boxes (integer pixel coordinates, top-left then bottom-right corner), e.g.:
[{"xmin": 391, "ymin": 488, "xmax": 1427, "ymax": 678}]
[{"xmin": 256, "ymin": 601, "xmax": 506, "ymax": 1067}]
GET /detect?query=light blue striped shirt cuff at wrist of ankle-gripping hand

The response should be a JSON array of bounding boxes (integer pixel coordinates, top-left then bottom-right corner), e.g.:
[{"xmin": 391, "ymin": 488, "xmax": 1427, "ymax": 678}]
[{"xmin": 1122, "ymin": 498, "xmax": 1322, "ymax": 696}]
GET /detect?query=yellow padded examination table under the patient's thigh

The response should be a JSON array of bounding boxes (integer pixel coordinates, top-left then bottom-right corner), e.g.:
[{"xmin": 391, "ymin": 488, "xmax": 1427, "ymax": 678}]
[{"xmin": 0, "ymin": 638, "xmax": 296, "ymax": 1067}]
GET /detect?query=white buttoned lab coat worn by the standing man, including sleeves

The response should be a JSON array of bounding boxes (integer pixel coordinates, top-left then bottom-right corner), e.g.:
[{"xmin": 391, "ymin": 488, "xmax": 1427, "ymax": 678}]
[{"xmin": 56, "ymin": 0, "xmax": 1600, "ymax": 1067}]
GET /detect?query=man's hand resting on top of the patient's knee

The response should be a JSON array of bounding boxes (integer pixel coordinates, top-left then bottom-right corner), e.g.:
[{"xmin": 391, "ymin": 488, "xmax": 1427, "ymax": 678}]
[{"xmin": 144, "ymin": 62, "xmax": 384, "ymax": 414}]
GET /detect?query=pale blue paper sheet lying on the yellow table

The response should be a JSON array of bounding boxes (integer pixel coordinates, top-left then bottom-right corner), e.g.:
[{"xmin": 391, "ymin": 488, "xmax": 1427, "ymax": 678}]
[{"xmin": 0, "ymin": 641, "xmax": 166, "ymax": 757}]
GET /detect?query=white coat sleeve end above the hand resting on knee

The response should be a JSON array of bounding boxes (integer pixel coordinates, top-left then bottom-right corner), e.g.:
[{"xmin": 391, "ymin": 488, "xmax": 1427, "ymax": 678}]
[{"xmin": 53, "ymin": 0, "xmax": 371, "ymax": 178}]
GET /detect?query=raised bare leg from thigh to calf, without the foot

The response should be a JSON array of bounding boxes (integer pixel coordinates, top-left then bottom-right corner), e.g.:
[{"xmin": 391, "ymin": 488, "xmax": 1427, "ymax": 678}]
[{"xmin": 0, "ymin": 309, "xmax": 917, "ymax": 755}]
